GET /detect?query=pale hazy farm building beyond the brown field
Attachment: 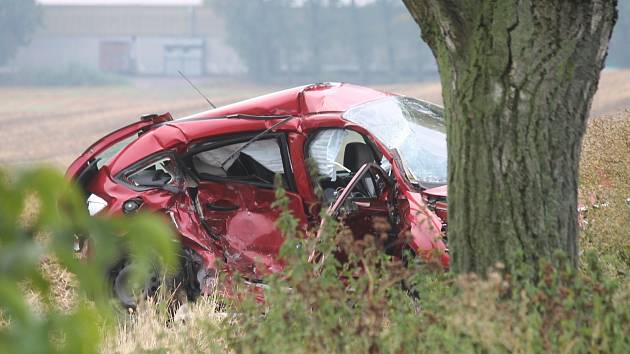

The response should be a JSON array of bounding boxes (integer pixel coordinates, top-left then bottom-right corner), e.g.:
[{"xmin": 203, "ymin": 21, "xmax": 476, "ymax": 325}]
[{"xmin": 13, "ymin": 0, "xmax": 246, "ymax": 76}]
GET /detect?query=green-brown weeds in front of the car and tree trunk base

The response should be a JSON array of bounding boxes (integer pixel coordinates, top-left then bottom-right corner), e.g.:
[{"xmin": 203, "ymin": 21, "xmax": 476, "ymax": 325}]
[{"xmin": 223, "ymin": 183, "xmax": 630, "ymax": 353}]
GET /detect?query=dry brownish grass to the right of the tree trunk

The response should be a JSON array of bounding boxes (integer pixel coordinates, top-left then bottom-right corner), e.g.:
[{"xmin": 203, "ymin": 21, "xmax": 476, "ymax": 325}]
[{"xmin": 580, "ymin": 109, "xmax": 630, "ymax": 277}]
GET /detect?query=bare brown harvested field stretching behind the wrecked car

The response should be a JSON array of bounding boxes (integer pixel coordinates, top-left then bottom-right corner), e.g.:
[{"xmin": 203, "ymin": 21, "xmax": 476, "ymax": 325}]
[{"xmin": 0, "ymin": 70, "xmax": 630, "ymax": 168}]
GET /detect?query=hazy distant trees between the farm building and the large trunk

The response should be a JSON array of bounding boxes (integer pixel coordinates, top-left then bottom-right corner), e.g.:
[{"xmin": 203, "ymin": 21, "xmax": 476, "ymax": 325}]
[{"xmin": 206, "ymin": 0, "xmax": 437, "ymax": 83}]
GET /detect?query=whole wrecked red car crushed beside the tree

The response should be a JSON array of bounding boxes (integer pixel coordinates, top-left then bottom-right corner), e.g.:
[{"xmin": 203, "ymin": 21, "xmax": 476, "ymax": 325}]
[{"xmin": 67, "ymin": 83, "xmax": 449, "ymax": 304}]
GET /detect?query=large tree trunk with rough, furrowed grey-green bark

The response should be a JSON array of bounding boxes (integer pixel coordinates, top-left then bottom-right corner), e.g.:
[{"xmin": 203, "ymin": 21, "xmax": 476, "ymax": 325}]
[{"xmin": 403, "ymin": 0, "xmax": 617, "ymax": 274}]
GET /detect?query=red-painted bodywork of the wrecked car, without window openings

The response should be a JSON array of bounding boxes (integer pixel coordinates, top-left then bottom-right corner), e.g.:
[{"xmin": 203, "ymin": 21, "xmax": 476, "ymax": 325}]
[{"xmin": 67, "ymin": 84, "xmax": 449, "ymax": 279}]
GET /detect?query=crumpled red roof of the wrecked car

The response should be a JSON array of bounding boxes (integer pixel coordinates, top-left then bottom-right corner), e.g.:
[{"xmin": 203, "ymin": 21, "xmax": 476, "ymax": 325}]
[{"xmin": 111, "ymin": 83, "xmax": 392, "ymax": 173}]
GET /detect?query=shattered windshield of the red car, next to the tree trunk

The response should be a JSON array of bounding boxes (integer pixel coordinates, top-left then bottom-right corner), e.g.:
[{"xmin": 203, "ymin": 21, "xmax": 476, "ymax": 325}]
[{"xmin": 344, "ymin": 96, "xmax": 447, "ymax": 185}]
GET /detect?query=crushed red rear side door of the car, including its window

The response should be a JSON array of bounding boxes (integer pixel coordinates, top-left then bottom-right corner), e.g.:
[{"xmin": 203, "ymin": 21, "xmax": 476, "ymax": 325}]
[{"xmin": 186, "ymin": 134, "xmax": 306, "ymax": 280}]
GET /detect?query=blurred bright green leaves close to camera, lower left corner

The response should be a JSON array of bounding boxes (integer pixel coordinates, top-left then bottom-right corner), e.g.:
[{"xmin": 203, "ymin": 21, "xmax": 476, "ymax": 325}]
[{"xmin": 0, "ymin": 169, "xmax": 175, "ymax": 353}]
